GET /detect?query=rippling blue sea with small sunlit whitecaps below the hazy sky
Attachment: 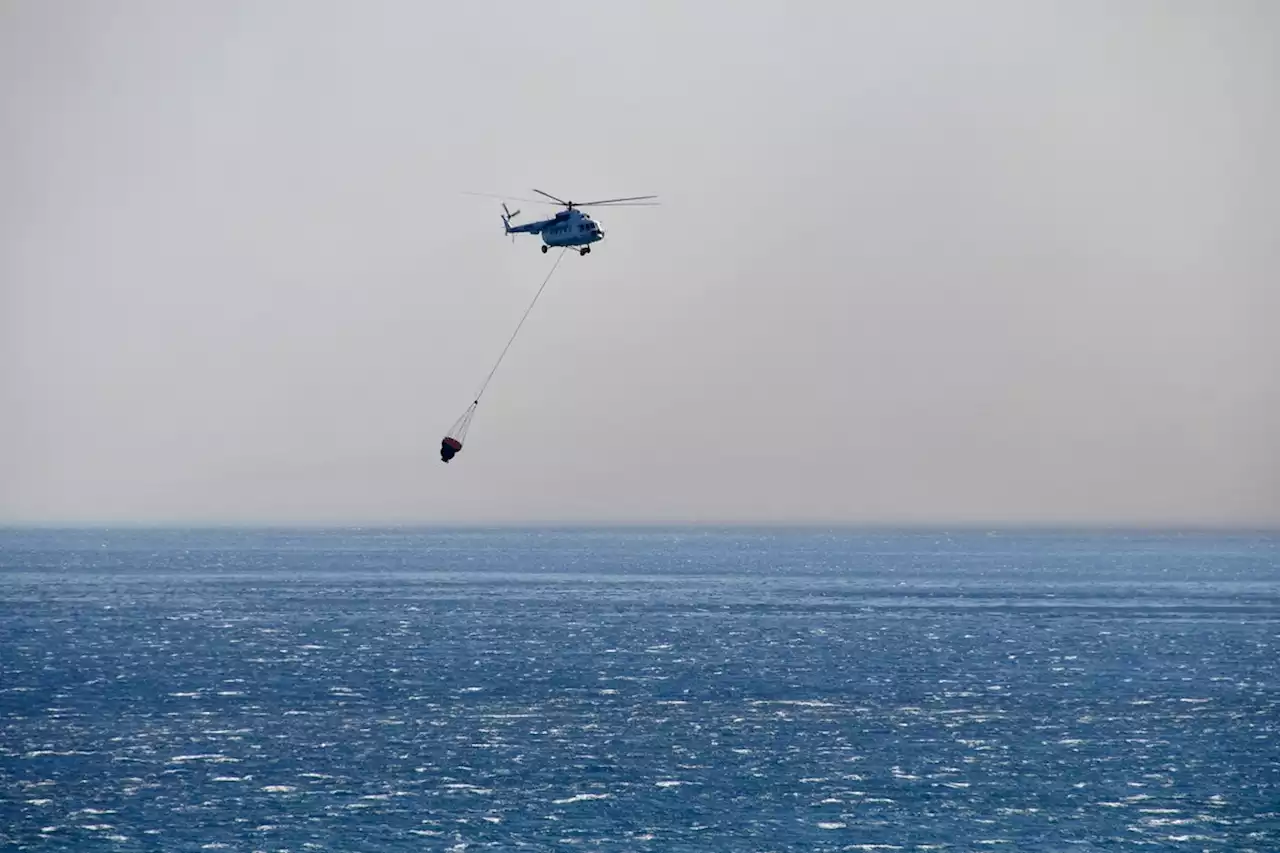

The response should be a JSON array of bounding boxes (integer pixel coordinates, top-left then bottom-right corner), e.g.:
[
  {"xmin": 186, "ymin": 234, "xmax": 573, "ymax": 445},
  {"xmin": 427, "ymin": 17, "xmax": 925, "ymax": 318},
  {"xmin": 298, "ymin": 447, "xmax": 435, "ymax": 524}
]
[{"xmin": 0, "ymin": 529, "xmax": 1280, "ymax": 853}]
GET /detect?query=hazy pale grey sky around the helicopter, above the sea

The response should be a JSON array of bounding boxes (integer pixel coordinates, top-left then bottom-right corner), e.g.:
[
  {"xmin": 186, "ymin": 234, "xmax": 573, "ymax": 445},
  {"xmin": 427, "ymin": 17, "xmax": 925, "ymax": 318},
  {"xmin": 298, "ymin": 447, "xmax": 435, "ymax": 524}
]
[{"xmin": 0, "ymin": 0, "xmax": 1280, "ymax": 525}]
